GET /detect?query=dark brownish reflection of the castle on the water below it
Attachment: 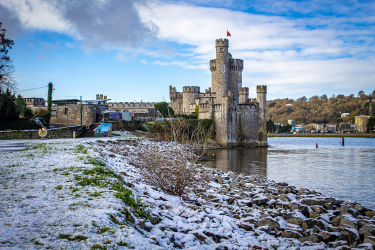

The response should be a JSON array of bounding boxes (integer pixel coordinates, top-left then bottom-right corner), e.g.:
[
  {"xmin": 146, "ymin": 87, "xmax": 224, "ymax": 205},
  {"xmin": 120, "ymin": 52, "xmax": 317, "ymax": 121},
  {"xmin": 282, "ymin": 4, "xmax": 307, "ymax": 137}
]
[{"xmin": 202, "ymin": 148, "xmax": 268, "ymax": 178}]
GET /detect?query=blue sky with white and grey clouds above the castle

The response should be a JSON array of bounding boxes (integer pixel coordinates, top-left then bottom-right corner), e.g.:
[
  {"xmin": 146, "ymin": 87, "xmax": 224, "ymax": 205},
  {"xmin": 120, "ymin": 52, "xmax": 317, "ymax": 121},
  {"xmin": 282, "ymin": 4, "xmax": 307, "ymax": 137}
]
[{"xmin": 0, "ymin": 0, "xmax": 375, "ymax": 102}]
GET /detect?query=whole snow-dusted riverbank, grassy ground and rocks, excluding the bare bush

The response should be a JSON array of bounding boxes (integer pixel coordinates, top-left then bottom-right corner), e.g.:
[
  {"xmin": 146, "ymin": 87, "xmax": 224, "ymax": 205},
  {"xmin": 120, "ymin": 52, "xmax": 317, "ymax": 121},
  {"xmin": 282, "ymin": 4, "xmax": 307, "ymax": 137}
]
[{"xmin": 0, "ymin": 138, "xmax": 375, "ymax": 249}]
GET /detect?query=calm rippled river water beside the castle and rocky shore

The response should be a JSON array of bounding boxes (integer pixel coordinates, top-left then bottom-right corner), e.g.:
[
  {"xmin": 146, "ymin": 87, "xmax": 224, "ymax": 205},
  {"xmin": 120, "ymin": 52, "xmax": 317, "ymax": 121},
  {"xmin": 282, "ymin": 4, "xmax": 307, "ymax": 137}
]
[{"xmin": 201, "ymin": 137, "xmax": 375, "ymax": 209}]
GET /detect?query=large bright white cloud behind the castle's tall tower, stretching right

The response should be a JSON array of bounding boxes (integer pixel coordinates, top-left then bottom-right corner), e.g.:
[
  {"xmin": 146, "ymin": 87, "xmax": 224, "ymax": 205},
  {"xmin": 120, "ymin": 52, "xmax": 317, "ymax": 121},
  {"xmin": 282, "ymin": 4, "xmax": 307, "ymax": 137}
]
[{"xmin": 140, "ymin": 1, "xmax": 375, "ymax": 97}]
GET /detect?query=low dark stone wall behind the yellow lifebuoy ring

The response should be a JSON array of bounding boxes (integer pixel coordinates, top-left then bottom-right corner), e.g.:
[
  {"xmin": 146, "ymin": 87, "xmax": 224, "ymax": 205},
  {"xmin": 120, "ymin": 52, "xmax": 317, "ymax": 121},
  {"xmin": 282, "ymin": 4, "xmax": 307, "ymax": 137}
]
[{"xmin": 0, "ymin": 126, "xmax": 84, "ymax": 140}]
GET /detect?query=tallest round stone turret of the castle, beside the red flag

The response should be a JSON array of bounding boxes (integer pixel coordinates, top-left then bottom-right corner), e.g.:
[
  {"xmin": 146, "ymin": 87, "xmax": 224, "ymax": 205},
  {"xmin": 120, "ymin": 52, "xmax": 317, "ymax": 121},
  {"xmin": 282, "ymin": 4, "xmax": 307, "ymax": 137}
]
[{"xmin": 210, "ymin": 38, "xmax": 229, "ymax": 97}]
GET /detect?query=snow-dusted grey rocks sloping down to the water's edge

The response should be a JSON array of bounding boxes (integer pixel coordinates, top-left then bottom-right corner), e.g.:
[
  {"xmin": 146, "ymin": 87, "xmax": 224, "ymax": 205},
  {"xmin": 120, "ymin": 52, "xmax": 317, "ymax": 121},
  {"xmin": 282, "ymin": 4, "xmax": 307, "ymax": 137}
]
[{"xmin": 98, "ymin": 142, "xmax": 375, "ymax": 249}]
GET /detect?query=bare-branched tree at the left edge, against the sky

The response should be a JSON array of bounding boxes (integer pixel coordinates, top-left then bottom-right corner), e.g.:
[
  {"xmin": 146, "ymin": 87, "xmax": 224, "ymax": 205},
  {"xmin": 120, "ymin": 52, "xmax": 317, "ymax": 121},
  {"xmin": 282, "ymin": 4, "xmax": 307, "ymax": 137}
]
[{"xmin": 0, "ymin": 22, "xmax": 16, "ymax": 93}]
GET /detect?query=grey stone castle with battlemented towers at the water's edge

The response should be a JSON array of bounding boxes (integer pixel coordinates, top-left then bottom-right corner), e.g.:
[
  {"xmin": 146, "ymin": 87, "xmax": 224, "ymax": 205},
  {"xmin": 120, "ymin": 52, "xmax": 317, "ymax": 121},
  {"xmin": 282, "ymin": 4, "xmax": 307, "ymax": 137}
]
[{"xmin": 169, "ymin": 39, "xmax": 268, "ymax": 147}]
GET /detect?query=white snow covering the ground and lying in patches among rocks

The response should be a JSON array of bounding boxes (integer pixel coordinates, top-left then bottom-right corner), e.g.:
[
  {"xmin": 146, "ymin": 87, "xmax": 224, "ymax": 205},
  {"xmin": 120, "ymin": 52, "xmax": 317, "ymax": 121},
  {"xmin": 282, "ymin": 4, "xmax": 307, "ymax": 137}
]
[{"xmin": 0, "ymin": 137, "xmax": 362, "ymax": 250}]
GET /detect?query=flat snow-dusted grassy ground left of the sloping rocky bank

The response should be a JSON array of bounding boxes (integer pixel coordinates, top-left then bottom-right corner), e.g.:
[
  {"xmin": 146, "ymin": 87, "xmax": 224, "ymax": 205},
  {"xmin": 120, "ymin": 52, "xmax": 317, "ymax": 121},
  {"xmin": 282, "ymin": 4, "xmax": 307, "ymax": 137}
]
[{"xmin": 0, "ymin": 139, "xmax": 160, "ymax": 249}]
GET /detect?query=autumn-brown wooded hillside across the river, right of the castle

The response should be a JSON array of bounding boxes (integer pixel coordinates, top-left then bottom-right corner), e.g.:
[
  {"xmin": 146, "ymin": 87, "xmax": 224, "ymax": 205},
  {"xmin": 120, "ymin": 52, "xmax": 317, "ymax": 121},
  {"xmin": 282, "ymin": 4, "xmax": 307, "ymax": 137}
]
[{"xmin": 267, "ymin": 90, "xmax": 375, "ymax": 124}]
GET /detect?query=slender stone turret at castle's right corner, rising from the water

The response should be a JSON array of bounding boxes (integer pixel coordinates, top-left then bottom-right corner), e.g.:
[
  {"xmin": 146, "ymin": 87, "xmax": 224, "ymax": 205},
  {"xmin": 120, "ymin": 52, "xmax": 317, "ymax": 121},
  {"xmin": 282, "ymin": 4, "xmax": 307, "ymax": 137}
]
[{"xmin": 257, "ymin": 85, "xmax": 268, "ymax": 147}]
